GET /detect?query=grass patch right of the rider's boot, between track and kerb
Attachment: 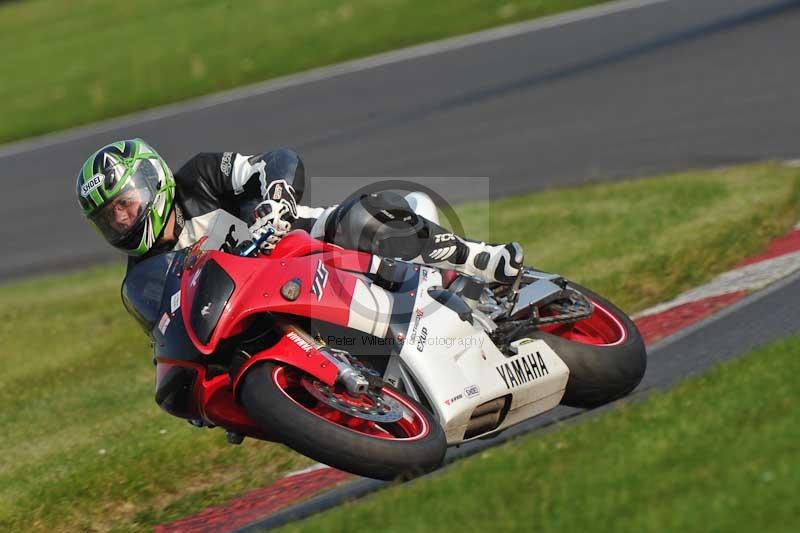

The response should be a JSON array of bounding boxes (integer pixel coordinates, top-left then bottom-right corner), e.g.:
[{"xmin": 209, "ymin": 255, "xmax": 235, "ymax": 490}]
[{"xmin": 457, "ymin": 164, "xmax": 800, "ymax": 311}]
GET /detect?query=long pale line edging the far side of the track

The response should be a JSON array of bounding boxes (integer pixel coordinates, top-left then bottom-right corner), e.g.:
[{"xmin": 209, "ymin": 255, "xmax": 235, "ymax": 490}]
[{"xmin": 0, "ymin": 0, "xmax": 670, "ymax": 157}]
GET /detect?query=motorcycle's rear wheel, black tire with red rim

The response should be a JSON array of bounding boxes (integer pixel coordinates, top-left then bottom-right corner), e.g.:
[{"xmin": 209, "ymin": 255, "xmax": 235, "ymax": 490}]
[{"xmin": 518, "ymin": 283, "xmax": 647, "ymax": 407}]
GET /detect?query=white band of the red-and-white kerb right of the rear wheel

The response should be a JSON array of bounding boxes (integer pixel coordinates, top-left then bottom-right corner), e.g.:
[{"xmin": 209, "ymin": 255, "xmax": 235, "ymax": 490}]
[{"xmin": 635, "ymin": 248, "xmax": 800, "ymax": 319}]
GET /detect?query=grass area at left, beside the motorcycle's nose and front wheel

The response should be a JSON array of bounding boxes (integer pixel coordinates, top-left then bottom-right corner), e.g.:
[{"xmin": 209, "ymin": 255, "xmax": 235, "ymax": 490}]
[{"xmin": 0, "ymin": 267, "xmax": 316, "ymax": 531}]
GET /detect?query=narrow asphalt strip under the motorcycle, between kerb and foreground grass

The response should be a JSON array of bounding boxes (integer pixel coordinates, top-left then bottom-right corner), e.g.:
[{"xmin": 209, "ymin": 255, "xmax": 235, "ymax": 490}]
[{"xmin": 237, "ymin": 273, "xmax": 800, "ymax": 533}]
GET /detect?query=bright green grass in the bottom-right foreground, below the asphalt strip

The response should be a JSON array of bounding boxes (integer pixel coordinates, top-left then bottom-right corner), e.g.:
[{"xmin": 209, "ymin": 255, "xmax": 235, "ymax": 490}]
[{"xmin": 283, "ymin": 337, "xmax": 800, "ymax": 533}]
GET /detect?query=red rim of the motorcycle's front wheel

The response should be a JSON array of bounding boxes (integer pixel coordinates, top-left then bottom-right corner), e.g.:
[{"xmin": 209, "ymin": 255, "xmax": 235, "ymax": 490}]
[{"xmin": 272, "ymin": 366, "xmax": 430, "ymax": 441}]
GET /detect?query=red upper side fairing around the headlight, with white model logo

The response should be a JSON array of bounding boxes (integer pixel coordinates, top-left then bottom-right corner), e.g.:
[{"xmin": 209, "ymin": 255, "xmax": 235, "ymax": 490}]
[{"xmin": 181, "ymin": 231, "xmax": 372, "ymax": 355}]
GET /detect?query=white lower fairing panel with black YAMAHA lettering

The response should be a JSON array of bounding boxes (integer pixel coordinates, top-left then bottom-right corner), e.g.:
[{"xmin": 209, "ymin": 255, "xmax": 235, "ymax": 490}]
[{"xmin": 400, "ymin": 267, "xmax": 569, "ymax": 444}]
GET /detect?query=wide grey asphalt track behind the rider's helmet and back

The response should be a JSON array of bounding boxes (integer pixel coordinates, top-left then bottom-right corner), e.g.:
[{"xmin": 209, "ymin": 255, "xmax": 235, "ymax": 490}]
[{"xmin": 0, "ymin": 0, "xmax": 800, "ymax": 281}]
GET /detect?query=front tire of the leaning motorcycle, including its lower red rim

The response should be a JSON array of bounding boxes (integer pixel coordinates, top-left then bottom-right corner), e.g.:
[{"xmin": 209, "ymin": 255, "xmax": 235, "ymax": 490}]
[{"xmin": 240, "ymin": 361, "xmax": 447, "ymax": 480}]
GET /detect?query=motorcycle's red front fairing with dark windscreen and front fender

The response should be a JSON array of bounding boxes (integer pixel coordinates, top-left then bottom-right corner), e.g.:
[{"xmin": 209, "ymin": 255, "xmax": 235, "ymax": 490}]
[{"xmin": 122, "ymin": 232, "xmax": 391, "ymax": 432}]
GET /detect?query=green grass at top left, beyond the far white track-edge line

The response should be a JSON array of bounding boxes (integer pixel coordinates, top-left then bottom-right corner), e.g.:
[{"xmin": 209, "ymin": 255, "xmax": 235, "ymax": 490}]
[{"xmin": 0, "ymin": 0, "xmax": 602, "ymax": 142}]
